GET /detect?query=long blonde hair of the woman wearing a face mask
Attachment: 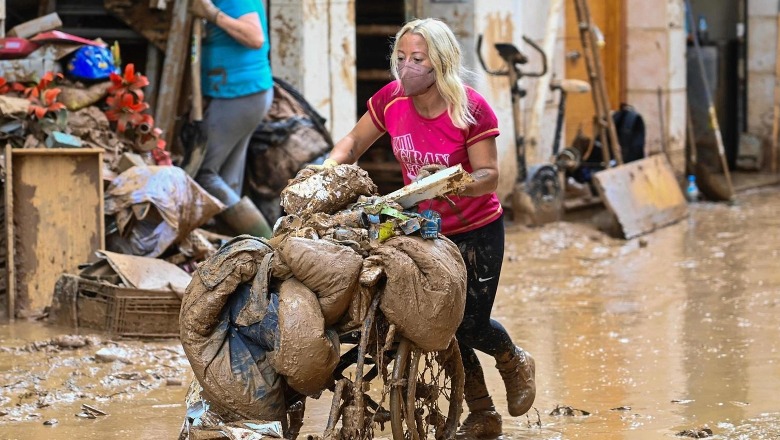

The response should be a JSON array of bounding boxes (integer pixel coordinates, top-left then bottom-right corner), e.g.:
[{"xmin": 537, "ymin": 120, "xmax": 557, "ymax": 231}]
[{"xmin": 390, "ymin": 18, "xmax": 476, "ymax": 128}]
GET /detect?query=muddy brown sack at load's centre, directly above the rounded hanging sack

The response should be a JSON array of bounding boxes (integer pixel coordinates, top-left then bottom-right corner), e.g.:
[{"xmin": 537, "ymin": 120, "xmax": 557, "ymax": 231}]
[{"xmin": 275, "ymin": 237, "xmax": 363, "ymax": 326}]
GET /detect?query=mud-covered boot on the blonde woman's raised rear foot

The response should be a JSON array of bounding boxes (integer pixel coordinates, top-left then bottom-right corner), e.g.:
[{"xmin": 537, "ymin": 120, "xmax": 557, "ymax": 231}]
[{"xmin": 496, "ymin": 347, "xmax": 536, "ymax": 417}]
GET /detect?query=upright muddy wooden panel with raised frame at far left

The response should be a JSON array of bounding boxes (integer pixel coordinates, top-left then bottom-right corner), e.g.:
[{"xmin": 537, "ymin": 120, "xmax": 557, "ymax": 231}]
[{"xmin": 5, "ymin": 147, "xmax": 105, "ymax": 319}]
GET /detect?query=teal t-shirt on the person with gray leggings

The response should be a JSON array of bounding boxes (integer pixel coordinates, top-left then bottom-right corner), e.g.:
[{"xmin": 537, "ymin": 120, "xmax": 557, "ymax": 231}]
[{"xmin": 201, "ymin": 0, "xmax": 273, "ymax": 98}]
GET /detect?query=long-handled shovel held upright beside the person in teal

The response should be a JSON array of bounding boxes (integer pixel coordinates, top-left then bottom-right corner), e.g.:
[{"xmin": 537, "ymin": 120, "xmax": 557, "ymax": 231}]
[{"xmin": 181, "ymin": 17, "xmax": 208, "ymax": 178}]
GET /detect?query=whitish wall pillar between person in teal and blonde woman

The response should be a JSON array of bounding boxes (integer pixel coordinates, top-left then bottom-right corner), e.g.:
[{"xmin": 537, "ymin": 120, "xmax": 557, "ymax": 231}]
[{"xmin": 269, "ymin": 0, "xmax": 357, "ymax": 140}]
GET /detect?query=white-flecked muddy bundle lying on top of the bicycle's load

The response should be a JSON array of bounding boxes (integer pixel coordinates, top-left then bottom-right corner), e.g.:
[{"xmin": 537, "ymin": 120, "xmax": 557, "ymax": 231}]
[{"xmin": 280, "ymin": 165, "xmax": 377, "ymax": 217}]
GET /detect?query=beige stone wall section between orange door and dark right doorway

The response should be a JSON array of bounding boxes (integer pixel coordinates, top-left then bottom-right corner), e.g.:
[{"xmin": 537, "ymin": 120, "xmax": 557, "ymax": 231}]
[{"xmin": 626, "ymin": 0, "xmax": 687, "ymax": 176}]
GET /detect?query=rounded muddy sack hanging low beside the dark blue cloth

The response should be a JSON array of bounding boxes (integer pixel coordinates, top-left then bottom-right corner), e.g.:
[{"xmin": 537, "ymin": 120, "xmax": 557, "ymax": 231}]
[{"xmin": 271, "ymin": 278, "xmax": 339, "ymax": 396}]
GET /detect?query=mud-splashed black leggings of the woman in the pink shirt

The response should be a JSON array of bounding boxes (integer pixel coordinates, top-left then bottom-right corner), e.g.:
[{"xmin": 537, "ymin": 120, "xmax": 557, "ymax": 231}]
[{"xmin": 448, "ymin": 216, "xmax": 514, "ymax": 400}]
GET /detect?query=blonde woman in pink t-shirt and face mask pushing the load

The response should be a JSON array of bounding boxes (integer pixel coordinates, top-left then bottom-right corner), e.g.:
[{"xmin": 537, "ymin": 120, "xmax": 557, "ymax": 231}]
[{"xmin": 324, "ymin": 18, "xmax": 536, "ymax": 438}]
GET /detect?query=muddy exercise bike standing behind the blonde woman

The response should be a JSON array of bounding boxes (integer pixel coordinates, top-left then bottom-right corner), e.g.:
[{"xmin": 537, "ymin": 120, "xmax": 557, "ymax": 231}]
[{"xmin": 477, "ymin": 35, "xmax": 590, "ymax": 225}]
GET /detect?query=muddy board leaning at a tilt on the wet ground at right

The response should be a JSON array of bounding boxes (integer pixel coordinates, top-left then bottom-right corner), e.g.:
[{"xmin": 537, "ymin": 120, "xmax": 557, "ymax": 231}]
[{"xmin": 593, "ymin": 154, "xmax": 688, "ymax": 239}]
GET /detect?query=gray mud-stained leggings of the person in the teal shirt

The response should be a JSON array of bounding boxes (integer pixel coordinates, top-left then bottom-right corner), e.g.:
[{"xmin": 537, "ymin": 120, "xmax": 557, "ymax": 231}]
[{"xmin": 195, "ymin": 88, "xmax": 274, "ymax": 206}]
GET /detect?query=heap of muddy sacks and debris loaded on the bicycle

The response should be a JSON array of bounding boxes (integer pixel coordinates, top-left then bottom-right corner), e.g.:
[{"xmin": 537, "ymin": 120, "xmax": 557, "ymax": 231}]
[{"xmin": 180, "ymin": 165, "xmax": 466, "ymax": 436}]
